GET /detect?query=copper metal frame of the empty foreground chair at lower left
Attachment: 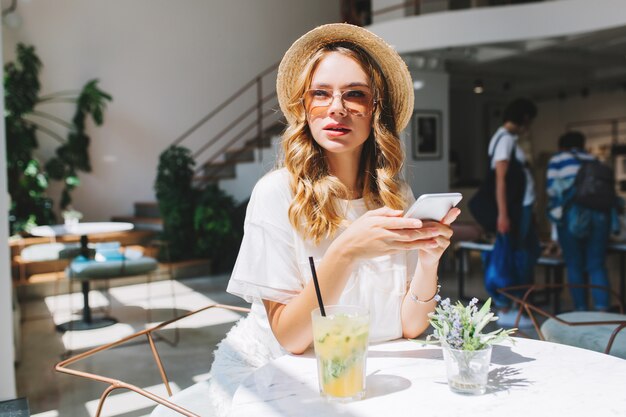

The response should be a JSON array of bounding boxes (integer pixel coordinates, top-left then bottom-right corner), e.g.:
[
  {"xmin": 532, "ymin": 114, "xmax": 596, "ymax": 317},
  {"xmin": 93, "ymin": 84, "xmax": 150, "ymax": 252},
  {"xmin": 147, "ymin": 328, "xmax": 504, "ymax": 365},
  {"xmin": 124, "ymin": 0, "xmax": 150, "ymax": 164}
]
[{"xmin": 54, "ymin": 304, "xmax": 250, "ymax": 417}]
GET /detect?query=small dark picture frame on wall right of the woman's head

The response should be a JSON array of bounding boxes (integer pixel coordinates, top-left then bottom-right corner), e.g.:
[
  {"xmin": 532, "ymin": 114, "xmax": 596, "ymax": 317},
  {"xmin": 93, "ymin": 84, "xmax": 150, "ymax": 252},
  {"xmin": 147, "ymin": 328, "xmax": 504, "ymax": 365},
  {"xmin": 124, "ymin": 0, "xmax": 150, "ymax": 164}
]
[{"xmin": 411, "ymin": 110, "xmax": 443, "ymax": 160}]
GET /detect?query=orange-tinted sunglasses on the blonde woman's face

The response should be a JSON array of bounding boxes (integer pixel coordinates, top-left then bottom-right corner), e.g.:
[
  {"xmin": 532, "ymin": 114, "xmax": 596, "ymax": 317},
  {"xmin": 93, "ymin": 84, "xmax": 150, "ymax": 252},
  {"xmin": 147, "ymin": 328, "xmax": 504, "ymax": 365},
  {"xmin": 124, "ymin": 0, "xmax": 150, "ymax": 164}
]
[{"xmin": 302, "ymin": 88, "xmax": 377, "ymax": 117}]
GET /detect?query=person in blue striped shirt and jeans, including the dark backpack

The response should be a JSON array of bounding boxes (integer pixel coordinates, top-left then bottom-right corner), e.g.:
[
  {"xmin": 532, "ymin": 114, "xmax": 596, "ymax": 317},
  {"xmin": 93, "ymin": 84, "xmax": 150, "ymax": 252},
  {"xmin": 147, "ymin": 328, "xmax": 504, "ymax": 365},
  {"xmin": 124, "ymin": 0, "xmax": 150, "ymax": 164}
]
[{"xmin": 546, "ymin": 132, "xmax": 617, "ymax": 311}]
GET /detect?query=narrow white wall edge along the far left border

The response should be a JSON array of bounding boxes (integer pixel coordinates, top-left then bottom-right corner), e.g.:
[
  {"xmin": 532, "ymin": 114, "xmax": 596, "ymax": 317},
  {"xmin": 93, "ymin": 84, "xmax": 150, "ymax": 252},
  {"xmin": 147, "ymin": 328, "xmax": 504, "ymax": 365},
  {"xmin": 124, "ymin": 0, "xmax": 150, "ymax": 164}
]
[{"xmin": 0, "ymin": 19, "xmax": 16, "ymax": 401}]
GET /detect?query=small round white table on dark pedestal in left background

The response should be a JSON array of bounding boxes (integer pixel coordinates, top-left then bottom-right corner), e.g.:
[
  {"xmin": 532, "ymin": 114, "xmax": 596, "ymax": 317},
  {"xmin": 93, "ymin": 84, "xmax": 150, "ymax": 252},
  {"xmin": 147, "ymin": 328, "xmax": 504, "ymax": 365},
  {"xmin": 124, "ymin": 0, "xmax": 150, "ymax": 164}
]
[{"xmin": 29, "ymin": 222, "xmax": 134, "ymax": 332}]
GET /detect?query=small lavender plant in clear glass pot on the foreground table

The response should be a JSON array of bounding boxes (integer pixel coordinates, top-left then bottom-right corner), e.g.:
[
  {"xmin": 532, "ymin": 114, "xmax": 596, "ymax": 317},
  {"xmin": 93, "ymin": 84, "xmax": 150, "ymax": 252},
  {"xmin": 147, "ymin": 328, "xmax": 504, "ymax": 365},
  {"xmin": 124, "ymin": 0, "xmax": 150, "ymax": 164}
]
[{"xmin": 426, "ymin": 298, "xmax": 517, "ymax": 395}]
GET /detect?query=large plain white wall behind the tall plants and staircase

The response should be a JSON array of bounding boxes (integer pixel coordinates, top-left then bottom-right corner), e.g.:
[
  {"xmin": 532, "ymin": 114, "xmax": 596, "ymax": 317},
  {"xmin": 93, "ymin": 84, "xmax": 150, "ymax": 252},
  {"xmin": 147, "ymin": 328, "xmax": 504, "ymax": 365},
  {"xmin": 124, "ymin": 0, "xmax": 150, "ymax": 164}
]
[{"xmin": 4, "ymin": 0, "xmax": 339, "ymax": 220}]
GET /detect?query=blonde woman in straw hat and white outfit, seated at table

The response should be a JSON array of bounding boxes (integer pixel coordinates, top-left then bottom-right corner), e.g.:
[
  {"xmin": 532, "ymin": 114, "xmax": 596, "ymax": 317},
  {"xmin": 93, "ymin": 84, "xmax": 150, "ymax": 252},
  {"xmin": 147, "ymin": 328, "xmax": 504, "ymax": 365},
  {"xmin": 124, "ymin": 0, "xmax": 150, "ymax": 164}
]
[{"xmin": 211, "ymin": 24, "xmax": 460, "ymax": 415}]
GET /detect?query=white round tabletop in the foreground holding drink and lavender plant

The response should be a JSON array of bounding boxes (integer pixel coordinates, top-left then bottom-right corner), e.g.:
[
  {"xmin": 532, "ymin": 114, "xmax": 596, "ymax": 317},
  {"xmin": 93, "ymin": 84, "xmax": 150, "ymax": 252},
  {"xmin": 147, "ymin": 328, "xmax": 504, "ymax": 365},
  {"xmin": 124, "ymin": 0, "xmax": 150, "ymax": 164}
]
[{"xmin": 230, "ymin": 338, "xmax": 626, "ymax": 417}]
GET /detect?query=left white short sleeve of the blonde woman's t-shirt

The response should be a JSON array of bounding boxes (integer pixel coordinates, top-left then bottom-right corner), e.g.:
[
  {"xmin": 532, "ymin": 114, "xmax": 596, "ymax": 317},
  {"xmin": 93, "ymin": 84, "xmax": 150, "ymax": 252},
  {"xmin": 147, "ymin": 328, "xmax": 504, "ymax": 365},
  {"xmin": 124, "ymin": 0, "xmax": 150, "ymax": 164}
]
[{"xmin": 227, "ymin": 170, "xmax": 305, "ymax": 304}]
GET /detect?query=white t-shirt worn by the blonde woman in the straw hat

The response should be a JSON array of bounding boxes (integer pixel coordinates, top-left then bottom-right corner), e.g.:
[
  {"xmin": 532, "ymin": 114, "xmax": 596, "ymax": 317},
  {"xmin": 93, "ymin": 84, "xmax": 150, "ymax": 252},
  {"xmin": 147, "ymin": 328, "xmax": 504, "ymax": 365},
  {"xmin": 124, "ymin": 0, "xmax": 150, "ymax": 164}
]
[{"xmin": 227, "ymin": 168, "xmax": 417, "ymax": 342}]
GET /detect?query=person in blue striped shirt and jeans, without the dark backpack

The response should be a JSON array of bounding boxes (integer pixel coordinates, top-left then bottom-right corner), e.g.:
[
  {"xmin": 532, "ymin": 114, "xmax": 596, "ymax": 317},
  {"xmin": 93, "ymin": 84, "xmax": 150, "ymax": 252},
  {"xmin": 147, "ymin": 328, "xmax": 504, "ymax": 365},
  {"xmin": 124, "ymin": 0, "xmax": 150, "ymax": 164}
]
[{"xmin": 546, "ymin": 132, "xmax": 611, "ymax": 310}]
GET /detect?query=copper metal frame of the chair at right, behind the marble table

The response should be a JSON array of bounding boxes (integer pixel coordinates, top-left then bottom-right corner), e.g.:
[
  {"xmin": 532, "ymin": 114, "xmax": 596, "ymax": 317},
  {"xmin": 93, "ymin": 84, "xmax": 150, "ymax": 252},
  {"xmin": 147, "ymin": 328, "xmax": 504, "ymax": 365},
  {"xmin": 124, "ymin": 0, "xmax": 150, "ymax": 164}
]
[{"xmin": 497, "ymin": 284, "xmax": 626, "ymax": 354}]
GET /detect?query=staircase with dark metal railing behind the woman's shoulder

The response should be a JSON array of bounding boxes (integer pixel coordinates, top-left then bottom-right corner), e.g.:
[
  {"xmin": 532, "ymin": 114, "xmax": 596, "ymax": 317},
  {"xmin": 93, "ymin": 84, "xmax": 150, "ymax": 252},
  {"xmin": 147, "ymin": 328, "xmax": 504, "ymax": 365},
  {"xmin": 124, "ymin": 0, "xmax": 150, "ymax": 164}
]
[{"xmin": 112, "ymin": 63, "xmax": 285, "ymax": 226}]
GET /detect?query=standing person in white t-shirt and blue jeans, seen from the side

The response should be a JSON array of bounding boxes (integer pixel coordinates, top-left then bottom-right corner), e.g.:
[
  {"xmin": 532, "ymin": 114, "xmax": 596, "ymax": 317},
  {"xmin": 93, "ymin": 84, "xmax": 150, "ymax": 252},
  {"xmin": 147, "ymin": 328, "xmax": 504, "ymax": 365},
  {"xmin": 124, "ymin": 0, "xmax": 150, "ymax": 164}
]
[{"xmin": 485, "ymin": 98, "xmax": 540, "ymax": 327}]
